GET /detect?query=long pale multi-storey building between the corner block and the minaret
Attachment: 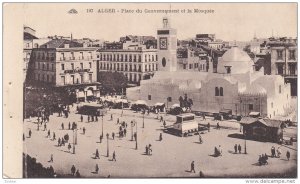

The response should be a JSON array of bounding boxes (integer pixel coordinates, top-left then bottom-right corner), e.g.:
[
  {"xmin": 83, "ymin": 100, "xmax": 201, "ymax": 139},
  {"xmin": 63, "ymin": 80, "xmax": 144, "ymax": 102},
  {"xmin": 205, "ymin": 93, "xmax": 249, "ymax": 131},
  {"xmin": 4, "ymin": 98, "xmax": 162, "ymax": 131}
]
[{"xmin": 97, "ymin": 45, "xmax": 157, "ymax": 84}]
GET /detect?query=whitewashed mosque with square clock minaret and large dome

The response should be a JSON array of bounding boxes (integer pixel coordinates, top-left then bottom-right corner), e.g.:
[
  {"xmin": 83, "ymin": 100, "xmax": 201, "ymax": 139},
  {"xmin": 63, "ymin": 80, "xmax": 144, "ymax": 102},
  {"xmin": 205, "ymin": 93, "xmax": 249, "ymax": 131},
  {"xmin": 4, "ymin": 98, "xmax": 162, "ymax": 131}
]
[{"xmin": 127, "ymin": 18, "xmax": 291, "ymax": 119}]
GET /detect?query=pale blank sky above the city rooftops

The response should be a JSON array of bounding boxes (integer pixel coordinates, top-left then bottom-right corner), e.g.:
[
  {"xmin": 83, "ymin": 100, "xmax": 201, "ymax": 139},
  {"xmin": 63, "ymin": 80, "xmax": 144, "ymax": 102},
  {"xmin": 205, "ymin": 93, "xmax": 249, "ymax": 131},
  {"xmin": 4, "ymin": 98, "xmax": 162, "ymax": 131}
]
[{"xmin": 23, "ymin": 3, "xmax": 297, "ymax": 41}]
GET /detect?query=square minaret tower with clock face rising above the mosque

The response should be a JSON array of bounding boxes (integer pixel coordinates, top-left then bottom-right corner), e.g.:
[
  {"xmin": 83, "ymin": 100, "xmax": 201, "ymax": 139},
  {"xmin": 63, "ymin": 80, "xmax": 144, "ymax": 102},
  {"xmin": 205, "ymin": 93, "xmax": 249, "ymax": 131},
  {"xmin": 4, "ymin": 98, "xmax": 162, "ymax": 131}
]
[{"xmin": 157, "ymin": 17, "xmax": 177, "ymax": 71}]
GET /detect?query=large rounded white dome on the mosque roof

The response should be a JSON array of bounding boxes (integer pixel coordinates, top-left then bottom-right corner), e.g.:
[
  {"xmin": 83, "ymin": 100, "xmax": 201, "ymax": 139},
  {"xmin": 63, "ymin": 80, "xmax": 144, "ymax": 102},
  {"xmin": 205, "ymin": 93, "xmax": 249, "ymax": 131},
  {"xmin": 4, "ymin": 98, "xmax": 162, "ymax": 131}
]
[{"xmin": 217, "ymin": 47, "xmax": 254, "ymax": 74}]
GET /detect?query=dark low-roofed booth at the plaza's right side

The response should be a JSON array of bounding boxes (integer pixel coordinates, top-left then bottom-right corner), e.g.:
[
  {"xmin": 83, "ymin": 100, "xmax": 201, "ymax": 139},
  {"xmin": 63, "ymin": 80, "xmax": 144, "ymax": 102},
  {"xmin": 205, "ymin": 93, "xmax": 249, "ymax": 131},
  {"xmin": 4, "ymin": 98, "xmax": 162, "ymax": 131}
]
[{"xmin": 240, "ymin": 117, "xmax": 284, "ymax": 142}]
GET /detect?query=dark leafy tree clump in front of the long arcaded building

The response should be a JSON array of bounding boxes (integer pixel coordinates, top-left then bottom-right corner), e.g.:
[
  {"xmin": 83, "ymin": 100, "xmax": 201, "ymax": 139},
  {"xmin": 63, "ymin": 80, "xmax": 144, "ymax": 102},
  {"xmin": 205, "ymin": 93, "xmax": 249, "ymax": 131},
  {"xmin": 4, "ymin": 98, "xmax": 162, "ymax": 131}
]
[{"xmin": 98, "ymin": 72, "xmax": 127, "ymax": 94}]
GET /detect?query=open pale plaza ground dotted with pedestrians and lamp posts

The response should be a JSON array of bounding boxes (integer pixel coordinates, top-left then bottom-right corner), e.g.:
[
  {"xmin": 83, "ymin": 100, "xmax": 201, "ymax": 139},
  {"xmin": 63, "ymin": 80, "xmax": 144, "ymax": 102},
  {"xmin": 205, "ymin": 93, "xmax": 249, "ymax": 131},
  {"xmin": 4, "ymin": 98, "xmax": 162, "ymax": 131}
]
[{"xmin": 23, "ymin": 104, "xmax": 297, "ymax": 178}]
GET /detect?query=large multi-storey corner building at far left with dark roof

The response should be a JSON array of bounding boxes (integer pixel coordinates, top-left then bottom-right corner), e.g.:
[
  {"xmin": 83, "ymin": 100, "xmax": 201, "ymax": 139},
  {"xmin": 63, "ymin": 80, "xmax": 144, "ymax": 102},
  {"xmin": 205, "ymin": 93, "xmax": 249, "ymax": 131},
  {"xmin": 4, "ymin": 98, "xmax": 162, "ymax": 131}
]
[{"xmin": 30, "ymin": 39, "xmax": 100, "ymax": 101}]
